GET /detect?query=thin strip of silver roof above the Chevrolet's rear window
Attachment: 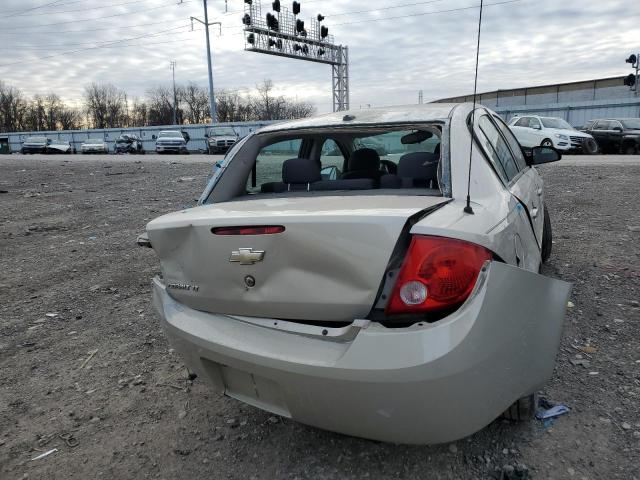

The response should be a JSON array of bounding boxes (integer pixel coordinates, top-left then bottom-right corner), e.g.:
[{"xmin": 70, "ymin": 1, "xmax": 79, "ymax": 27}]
[{"xmin": 260, "ymin": 103, "xmax": 461, "ymax": 133}]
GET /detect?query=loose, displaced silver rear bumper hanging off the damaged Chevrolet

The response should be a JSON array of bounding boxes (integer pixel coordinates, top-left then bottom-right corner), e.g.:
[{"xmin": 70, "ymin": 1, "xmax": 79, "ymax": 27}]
[{"xmin": 154, "ymin": 263, "xmax": 570, "ymax": 444}]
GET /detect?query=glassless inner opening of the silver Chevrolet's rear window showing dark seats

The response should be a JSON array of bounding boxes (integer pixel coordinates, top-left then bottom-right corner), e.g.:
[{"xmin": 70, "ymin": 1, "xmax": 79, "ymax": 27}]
[{"xmin": 246, "ymin": 129, "xmax": 441, "ymax": 196}]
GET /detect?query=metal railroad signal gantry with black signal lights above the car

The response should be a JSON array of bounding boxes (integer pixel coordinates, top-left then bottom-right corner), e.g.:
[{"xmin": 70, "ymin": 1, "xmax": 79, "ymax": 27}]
[{"xmin": 242, "ymin": 0, "xmax": 349, "ymax": 112}]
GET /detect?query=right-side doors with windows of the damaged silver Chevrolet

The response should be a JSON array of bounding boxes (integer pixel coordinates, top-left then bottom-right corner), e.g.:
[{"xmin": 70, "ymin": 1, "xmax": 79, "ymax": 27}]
[{"xmin": 477, "ymin": 112, "xmax": 544, "ymax": 271}]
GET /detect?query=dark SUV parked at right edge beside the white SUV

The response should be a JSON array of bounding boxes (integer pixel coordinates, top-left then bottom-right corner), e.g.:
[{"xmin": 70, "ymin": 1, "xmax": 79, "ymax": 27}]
[{"xmin": 582, "ymin": 118, "xmax": 640, "ymax": 155}]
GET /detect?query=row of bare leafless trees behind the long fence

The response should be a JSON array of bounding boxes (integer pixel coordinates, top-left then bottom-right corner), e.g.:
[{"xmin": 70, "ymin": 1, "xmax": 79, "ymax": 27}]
[{"xmin": 0, "ymin": 80, "xmax": 315, "ymax": 132}]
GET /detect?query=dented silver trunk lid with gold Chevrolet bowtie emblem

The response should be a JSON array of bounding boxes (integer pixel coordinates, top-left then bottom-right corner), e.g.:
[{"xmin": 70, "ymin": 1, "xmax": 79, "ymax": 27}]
[{"xmin": 147, "ymin": 195, "xmax": 447, "ymax": 321}]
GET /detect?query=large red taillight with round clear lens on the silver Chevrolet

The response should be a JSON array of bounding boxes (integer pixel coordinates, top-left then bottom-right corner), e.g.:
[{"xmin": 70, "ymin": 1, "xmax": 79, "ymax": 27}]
[{"xmin": 386, "ymin": 235, "xmax": 492, "ymax": 315}]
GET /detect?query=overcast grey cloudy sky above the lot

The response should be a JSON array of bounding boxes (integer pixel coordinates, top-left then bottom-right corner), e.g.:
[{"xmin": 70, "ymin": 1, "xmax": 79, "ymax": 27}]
[{"xmin": 0, "ymin": 0, "xmax": 640, "ymax": 112}]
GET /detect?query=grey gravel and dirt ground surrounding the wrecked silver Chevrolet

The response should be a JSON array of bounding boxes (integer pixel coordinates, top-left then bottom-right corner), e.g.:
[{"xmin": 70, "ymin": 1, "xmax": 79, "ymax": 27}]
[{"xmin": 0, "ymin": 155, "xmax": 640, "ymax": 480}]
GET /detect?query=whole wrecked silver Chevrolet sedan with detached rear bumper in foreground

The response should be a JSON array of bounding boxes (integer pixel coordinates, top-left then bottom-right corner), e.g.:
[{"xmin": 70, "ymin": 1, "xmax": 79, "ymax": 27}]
[{"xmin": 144, "ymin": 104, "xmax": 570, "ymax": 444}]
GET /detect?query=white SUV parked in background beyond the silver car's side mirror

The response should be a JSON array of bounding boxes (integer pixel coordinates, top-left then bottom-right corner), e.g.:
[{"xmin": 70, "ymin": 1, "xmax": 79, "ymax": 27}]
[{"xmin": 509, "ymin": 115, "xmax": 598, "ymax": 154}]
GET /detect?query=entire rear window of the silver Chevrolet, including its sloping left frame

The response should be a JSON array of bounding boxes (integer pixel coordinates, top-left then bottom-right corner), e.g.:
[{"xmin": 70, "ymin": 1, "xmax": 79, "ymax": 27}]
[{"xmin": 206, "ymin": 122, "xmax": 443, "ymax": 203}]
